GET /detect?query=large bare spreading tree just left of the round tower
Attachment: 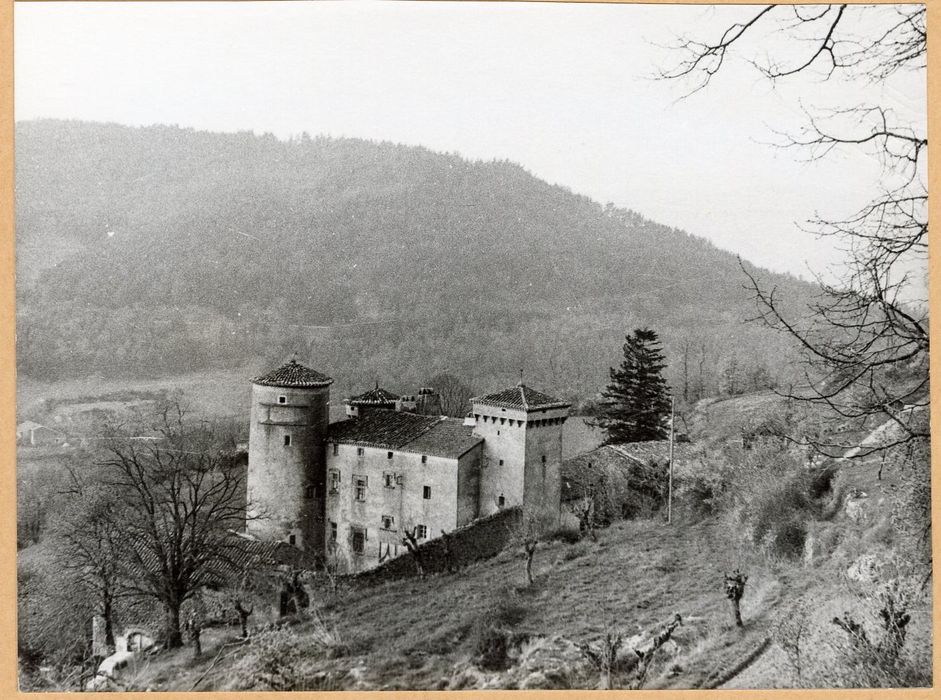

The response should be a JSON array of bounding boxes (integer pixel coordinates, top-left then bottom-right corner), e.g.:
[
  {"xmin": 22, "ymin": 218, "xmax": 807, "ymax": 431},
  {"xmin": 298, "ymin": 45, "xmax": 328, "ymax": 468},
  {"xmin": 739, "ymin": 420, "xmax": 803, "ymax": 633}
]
[{"xmin": 100, "ymin": 405, "xmax": 252, "ymax": 647}]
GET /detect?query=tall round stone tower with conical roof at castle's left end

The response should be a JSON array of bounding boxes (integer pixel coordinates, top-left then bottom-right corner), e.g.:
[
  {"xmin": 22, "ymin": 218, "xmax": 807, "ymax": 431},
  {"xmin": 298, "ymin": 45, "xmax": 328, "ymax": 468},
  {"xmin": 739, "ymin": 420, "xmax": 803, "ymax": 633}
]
[{"xmin": 246, "ymin": 360, "xmax": 333, "ymax": 553}]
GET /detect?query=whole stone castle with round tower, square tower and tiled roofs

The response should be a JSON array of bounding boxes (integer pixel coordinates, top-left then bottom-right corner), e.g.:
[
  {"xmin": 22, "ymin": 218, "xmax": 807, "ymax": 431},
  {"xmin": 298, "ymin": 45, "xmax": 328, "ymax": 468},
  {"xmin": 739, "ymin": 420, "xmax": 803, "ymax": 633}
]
[{"xmin": 246, "ymin": 360, "xmax": 570, "ymax": 571}]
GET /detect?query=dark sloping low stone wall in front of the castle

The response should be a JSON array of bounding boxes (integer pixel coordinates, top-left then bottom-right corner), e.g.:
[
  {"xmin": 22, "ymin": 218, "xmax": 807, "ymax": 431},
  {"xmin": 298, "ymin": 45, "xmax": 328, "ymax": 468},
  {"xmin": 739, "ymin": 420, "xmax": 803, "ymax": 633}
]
[{"xmin": 347, "ymin": 507, "xmax": 522, "ymax": 586}]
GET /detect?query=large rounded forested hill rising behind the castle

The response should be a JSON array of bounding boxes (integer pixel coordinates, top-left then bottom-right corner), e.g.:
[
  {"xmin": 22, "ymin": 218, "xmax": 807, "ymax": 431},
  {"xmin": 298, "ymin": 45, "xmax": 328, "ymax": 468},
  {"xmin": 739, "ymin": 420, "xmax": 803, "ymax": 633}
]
[{"xmin": 16, "ymin": 120, "xmax": 812, "ymax": 396}]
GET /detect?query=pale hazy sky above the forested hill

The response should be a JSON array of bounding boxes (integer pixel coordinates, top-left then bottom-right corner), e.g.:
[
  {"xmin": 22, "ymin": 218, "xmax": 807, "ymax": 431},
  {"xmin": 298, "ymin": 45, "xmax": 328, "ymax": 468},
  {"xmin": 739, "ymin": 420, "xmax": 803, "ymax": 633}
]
[{"xmin": 15, "ymin": 2, "xmax": 926, "ymax": 276}]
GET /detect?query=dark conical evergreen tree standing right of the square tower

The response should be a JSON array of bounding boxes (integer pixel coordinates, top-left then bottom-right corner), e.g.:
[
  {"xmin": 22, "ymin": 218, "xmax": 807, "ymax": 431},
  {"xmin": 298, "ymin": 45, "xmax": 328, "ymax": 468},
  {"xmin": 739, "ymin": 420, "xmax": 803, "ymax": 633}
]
[{"xmin": 594, "ymin": 328, "xmax": 670, "ymax": 444}]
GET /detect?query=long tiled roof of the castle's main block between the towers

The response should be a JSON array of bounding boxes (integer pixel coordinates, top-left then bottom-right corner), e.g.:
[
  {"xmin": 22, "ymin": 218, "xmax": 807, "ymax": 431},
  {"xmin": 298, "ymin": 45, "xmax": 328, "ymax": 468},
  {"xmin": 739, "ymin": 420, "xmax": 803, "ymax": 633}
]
[{"xmin": 329, "ymin": 411, "xmax": 482, "ymax": 459}]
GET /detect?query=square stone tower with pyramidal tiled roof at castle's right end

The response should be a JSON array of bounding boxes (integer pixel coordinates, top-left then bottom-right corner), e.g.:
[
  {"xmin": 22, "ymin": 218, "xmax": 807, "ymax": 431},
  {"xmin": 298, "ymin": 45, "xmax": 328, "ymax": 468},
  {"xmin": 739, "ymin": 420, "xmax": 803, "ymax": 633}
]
[{"xmin": 471, "ymin": 382, "xmax": 571, "ymax": 524}]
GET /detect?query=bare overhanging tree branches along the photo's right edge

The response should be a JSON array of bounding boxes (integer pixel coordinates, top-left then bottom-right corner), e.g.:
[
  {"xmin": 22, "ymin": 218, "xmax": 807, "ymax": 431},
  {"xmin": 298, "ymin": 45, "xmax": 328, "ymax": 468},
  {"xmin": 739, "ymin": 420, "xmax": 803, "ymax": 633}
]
[{"xmin": 660, "ymin": 5, "xmax": 928, "ymax": 456}]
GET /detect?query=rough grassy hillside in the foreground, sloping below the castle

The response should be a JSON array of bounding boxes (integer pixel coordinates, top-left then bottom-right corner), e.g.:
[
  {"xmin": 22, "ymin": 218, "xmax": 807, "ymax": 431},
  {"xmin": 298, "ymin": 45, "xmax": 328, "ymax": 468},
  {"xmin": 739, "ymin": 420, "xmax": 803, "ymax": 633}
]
[{"xmin": 90, "ymin": 504, "xmax": 930, "ymax": 691}]
